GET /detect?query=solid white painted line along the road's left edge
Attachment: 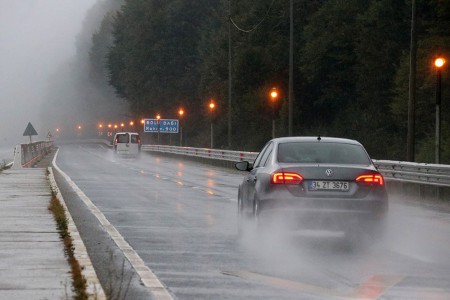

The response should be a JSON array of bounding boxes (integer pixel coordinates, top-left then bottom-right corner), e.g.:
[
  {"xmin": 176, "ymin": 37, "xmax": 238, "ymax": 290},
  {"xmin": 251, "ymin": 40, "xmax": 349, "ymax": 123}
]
[{"xmin": 53, "ymin": 148, "xmax": 174, "ymax": 300}]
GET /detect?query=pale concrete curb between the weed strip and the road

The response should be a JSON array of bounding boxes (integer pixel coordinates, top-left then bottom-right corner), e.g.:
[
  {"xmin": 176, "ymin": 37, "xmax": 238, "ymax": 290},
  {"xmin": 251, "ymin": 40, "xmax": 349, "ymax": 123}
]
[{"xmin": 48, "ymin": 167, "xmax": 106, "ymax": 300}]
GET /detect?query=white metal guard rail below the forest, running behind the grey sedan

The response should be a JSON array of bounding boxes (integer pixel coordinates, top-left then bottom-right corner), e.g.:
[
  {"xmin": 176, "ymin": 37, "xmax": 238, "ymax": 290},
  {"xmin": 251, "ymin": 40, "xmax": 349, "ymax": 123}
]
[{"xmin": 142, "ymin": 145, "xmax": 450, "ymax": 187}]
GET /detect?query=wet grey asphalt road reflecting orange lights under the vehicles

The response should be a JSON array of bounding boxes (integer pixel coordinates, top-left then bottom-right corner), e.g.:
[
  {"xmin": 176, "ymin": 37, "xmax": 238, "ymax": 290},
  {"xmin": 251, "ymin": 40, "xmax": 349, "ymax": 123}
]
[{"xmin": 56, "ymin": 145, "xmax": 450, "ymax": 299}]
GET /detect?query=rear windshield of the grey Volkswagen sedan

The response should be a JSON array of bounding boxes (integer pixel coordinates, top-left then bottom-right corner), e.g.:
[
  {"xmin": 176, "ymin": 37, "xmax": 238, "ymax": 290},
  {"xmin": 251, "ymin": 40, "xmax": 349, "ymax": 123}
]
[{"xmin": 278, "ymin": 142, "xmax": 371, "ymax": 165}]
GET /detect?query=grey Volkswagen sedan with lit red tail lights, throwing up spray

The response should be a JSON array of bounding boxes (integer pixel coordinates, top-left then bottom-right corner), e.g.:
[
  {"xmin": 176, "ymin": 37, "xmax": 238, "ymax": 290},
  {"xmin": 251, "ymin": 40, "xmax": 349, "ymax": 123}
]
[{"xmin": 236, "ymin": 137, "xmax": 388, "ymax": 242}]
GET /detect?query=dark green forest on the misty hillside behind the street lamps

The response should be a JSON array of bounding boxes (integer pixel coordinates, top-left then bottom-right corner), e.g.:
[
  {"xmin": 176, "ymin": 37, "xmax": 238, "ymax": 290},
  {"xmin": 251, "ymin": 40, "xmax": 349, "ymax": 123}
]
[{"xmin": 90, "ymin": 0, "xmax": 450, "ymax": 163}]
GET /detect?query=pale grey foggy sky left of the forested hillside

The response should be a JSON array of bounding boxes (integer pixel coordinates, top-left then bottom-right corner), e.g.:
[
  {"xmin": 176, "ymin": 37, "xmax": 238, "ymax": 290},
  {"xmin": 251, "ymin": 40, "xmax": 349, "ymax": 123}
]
[{"xmin": 0, "ymin": 0, "xmax": 114, "ymax": 148}]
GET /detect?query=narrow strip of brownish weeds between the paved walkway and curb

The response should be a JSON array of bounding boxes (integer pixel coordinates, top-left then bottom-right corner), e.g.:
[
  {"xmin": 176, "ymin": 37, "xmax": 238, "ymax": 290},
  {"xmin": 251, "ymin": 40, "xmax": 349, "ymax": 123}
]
[{"xmin": 48, "ymin": 191, "xmax": 89, "ymax": 300}]
